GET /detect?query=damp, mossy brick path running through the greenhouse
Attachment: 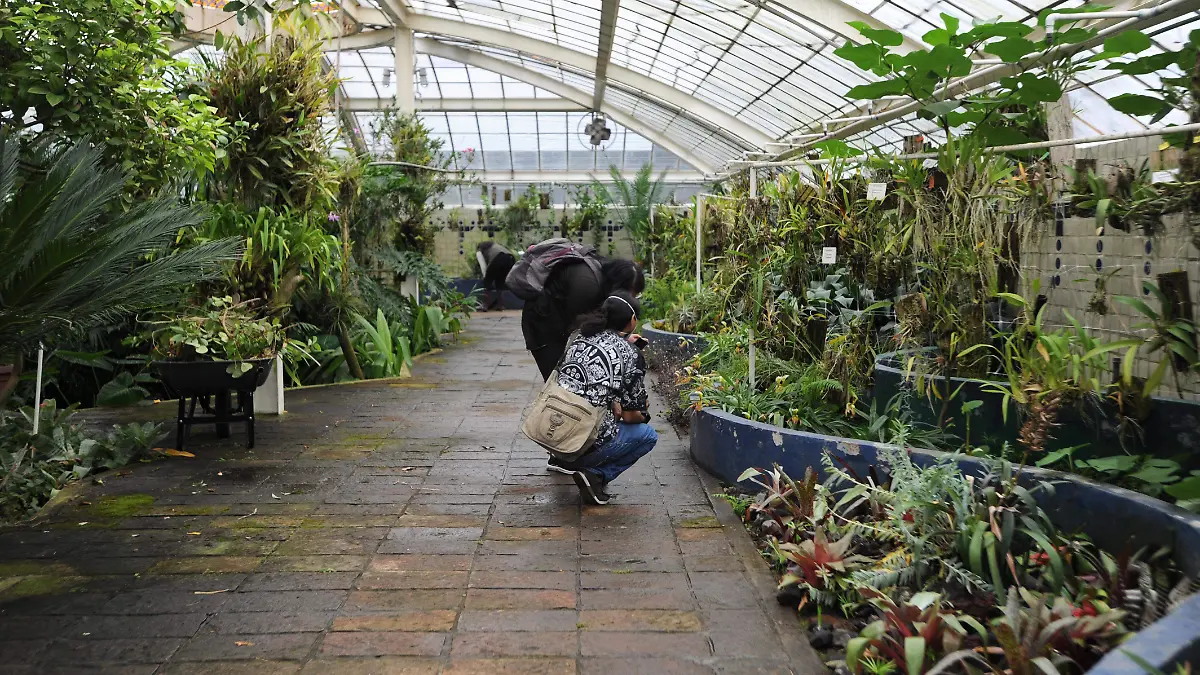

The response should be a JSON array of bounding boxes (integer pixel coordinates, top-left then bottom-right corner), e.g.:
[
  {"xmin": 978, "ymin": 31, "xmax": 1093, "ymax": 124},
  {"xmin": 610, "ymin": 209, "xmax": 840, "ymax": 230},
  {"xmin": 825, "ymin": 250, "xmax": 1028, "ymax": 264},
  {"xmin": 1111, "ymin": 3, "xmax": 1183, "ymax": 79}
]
[{"xmin": 0, "ymin": 312, "xmax": 818, "ymax": 675}]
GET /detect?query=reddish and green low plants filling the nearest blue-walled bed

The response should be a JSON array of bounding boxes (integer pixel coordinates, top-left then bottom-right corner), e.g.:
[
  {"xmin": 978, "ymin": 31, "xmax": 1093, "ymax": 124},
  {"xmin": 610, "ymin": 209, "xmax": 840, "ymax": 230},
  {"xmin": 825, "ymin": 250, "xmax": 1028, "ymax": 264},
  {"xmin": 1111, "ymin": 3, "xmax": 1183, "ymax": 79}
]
[{"xmin": 719, "ymin": 446, "xmax": 1195, "ymax": 674}]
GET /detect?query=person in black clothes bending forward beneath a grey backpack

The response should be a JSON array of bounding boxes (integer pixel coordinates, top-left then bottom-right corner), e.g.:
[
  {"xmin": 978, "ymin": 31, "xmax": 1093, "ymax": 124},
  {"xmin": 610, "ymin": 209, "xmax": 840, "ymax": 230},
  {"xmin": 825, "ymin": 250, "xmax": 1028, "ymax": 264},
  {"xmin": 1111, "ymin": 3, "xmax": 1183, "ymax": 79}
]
[{"xmin": 521, "ymin": 254, "xmax": 646, "ymax": 380}]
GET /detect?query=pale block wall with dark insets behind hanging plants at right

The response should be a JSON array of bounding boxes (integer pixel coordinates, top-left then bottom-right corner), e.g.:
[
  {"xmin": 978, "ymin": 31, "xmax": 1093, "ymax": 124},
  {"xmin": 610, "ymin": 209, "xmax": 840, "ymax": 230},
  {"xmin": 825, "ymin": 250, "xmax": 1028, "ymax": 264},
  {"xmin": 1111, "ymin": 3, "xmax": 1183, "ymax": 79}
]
[{"xmin": 1021, "ymin": 137, "xmax": 1200, "ymax": 401}]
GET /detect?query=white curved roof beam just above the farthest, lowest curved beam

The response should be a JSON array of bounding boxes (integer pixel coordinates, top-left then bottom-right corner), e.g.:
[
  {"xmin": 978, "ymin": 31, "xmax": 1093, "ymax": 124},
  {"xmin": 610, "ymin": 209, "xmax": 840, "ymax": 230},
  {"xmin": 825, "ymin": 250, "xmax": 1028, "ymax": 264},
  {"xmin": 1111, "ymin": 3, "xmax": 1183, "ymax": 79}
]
[{"xmin": 408, "ymin": 13, "xmax": 775, "ymax": 149}]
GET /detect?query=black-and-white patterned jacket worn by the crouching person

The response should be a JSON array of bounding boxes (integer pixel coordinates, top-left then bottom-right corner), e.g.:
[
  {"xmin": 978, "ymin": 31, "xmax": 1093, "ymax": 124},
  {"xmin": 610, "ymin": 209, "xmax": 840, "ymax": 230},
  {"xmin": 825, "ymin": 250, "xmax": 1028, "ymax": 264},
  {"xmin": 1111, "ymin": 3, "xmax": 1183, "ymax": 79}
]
[{"xmin": 558, "ymin": 330, "xmax": 647, "ymax": 446}]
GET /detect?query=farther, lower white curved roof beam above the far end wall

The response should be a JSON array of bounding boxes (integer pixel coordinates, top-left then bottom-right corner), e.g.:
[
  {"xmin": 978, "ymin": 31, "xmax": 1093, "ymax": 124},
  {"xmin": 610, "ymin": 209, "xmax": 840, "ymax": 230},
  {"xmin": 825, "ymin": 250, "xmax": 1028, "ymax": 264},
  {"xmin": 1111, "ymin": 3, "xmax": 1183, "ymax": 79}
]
[{"xmin": 409, "ymin": 37, "xmax": 713, "ymax": 174}]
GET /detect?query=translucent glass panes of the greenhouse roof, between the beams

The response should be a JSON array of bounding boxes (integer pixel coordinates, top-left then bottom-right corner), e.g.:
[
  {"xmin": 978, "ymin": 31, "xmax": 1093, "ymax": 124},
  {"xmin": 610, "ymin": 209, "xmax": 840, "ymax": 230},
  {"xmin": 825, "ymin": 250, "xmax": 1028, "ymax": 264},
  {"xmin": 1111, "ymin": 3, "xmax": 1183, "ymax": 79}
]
[{"xmin": 185, "ymin": 0, "xmax": 1200, "ymax": 171}]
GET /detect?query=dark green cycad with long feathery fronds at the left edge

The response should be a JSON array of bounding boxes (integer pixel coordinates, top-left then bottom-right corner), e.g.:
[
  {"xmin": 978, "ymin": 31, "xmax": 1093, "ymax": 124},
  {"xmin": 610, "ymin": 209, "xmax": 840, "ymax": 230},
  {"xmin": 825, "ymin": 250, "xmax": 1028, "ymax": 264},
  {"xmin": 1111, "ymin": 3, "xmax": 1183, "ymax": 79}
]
[{"xmin": 0, "ymin": 137, "xmax": 239, "ymax": 401}]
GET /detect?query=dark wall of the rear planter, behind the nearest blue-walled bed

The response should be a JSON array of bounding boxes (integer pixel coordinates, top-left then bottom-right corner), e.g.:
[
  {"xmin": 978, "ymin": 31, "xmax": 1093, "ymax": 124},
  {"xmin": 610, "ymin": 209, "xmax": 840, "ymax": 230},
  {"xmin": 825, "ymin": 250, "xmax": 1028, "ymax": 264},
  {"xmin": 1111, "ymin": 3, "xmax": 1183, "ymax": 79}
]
[{"xmin": 875, "ymin": 350, "xmax": 1200, "ymax": 461}]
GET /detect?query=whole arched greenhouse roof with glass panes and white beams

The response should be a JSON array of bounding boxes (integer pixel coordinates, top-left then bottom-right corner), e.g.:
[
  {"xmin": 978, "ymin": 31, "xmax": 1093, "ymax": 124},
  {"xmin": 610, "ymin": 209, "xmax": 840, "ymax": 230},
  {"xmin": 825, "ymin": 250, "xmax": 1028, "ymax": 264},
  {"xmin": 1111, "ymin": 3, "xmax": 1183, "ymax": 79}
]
[{"xmin": 177, "ymin": 0, "xmax": 1200, "ymax": 179}]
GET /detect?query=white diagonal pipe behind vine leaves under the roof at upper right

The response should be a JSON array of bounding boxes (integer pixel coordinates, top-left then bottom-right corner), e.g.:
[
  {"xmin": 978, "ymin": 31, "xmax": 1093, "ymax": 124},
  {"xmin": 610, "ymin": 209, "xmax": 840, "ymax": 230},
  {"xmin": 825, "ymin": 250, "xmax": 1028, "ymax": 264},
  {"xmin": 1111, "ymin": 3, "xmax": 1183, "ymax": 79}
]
[{"xmin": 782, "ymin": 0, "xmax": 1200, "ymax": 157}]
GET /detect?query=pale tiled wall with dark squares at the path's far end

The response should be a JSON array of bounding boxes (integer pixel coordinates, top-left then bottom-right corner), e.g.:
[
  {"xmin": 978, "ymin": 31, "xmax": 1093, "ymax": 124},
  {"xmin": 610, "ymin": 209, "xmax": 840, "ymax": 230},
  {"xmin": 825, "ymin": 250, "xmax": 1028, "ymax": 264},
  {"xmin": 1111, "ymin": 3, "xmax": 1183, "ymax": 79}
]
[{"xmin": 432, "ymin": 208, "xmax": 634, "ymax": 277}]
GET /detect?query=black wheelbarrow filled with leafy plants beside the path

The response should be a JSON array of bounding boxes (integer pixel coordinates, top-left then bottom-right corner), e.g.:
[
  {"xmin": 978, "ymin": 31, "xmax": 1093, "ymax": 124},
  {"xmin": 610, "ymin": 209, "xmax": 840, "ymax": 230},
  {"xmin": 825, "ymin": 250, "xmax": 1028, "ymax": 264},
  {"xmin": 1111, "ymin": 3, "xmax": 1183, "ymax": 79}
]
[{"xmin": 134, "ymin": 297, "xmax": 287, "ymax": 449}]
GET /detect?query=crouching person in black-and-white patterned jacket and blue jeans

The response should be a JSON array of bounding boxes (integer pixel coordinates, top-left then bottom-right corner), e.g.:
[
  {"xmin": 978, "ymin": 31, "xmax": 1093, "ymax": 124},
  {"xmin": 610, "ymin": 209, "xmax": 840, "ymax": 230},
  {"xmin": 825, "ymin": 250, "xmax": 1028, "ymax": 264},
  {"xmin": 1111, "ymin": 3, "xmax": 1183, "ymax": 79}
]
[{"xmin": 547, "ymin": 291, "xmax": 659, "ymax": 504}]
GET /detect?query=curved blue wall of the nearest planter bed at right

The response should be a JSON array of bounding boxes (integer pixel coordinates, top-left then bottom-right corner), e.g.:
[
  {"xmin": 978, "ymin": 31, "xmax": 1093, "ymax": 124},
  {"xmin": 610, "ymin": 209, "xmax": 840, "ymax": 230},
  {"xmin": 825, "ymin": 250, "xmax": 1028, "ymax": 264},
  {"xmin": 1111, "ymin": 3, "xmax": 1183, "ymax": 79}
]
[{"xmin": 691, "ymin": 408, "xmax": 1200, "ymax": 675}]
